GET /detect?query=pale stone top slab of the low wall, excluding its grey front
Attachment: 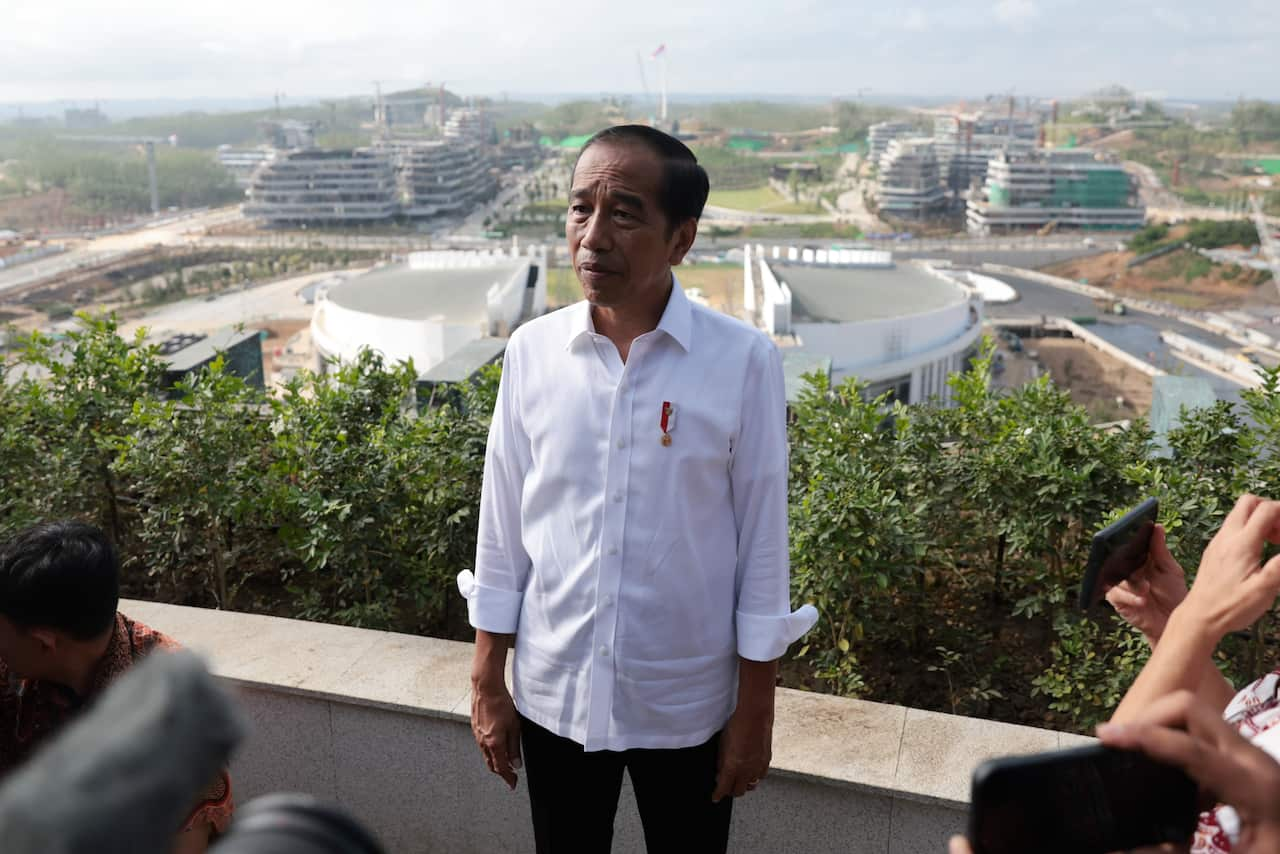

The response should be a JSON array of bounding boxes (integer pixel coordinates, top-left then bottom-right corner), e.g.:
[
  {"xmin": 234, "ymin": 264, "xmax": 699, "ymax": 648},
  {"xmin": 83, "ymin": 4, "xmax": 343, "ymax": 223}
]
[{"xmin": 120, "ymin": 600, "xmax": 1092, "ymax": 809}]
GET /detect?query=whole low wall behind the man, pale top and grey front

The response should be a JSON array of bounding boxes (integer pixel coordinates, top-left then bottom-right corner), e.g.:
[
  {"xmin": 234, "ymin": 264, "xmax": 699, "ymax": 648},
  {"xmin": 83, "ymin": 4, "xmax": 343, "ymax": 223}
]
[{"xmin": 120, "ymin": 600, "xmax": 1082, "ymax": 854}]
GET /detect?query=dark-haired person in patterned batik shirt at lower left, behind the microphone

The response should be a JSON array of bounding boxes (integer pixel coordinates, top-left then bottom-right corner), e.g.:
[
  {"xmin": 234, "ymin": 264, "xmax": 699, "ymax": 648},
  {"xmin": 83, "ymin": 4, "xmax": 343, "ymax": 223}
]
[{"xmin": 0, "ymin": 521, "xmax": 233, "ymax": 854}]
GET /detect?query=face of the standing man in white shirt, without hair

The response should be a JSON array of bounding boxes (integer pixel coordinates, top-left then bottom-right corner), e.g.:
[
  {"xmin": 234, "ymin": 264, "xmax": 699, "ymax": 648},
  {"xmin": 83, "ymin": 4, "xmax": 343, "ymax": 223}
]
[{"xmin": 564, "ymin": 142, "xmax": 696, "ymax": 309}]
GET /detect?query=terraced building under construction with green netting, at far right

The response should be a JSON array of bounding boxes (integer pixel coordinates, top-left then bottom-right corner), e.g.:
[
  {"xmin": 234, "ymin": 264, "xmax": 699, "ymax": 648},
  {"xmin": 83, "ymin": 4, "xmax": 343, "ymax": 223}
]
[{"xmin": 966, "ymin": 149, "xmax": 1146, "ymax": 234}]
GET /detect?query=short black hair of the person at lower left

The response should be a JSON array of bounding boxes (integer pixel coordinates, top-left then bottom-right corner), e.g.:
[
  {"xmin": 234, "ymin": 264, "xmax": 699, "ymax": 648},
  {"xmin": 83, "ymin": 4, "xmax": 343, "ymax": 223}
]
[{"xmin": 0, "ymin": 521, "xmax": 120, "ymax": 640}]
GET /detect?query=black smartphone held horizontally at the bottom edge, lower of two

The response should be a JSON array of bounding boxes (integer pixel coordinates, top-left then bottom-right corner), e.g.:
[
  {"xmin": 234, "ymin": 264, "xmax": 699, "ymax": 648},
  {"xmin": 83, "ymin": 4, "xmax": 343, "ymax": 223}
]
[{"xmin": 969, "ymin": 745, "xmax": 1199, "ymax": 854}]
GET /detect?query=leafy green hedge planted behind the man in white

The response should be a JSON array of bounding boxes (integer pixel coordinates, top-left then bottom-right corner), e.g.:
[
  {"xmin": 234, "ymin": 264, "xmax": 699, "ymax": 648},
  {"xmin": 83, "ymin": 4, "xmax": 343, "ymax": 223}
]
[{"xmin": 0, "ymin": 319, "xmax": 1280, "ymax": 729}]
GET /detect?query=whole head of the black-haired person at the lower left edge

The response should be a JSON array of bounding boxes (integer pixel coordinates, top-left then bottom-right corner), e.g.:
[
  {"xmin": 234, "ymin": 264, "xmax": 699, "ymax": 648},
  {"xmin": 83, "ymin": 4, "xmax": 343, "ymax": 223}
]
[{"xmin": 0, "ymin": 521, "xmax": 120, "ymax": 688}]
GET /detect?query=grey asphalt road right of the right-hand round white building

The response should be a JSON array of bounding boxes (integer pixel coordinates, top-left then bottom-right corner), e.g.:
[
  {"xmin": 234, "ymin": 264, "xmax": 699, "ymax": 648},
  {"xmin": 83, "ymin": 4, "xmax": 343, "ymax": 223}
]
[{"xmin": 986, "ymin": 273, "xmax": 1242, "ymax": 403}]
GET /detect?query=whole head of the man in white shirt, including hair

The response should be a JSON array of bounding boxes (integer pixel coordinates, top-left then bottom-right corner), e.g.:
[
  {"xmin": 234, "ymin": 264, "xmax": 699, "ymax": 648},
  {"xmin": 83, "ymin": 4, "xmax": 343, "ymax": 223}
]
[{"xmin": 564, "ymin": 124, "xmax": 710, "ymax": 309}]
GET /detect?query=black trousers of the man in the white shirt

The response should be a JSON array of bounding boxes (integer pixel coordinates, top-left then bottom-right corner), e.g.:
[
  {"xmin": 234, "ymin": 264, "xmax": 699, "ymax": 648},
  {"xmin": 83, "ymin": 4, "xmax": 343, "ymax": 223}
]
[{"xmin": 520, "ymin": 716, "xmax": 733, "ymax": 854}]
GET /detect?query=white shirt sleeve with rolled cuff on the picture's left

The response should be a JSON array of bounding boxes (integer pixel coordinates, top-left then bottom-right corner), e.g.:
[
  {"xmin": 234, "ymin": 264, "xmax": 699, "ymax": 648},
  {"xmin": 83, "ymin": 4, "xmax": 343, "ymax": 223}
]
[{"xmin": 458, "ymin": 338, "xmax": 532, "ymax": 634}]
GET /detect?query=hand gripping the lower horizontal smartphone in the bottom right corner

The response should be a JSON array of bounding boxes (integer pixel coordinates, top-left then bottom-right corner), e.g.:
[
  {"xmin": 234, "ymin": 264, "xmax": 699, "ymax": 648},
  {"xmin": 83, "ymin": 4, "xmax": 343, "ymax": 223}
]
[{"xmin": 1098, "ymin": 691, "xmax": 1280, "ymax": 854}]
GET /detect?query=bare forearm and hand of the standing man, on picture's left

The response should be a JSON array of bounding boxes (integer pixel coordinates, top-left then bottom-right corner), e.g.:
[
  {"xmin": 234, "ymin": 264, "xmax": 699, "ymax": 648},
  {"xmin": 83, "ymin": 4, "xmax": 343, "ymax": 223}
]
[{"xmin": 471, "ymin": 630, "xmax": 521, "ymax": 789}]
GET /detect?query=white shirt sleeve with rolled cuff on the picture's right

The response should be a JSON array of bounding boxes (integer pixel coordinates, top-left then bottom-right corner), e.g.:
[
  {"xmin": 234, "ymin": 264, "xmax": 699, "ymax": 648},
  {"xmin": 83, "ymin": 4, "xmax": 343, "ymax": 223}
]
[{"xmin": 730, "ymin": 337, "xmax": 818, "ymax": 661}]
